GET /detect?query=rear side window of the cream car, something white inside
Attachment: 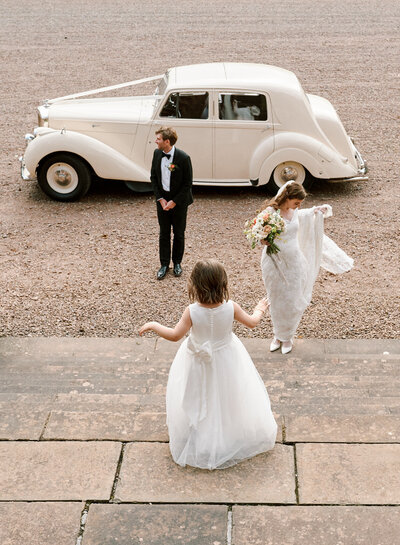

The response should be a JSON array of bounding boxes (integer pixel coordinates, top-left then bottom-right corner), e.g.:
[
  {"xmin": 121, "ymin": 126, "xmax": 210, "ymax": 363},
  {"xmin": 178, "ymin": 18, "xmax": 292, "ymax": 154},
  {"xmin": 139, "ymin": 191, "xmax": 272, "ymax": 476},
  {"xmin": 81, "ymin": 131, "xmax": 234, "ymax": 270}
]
[{"xmin": 218, "ymin": 93, "xmax": 268, "ymax": 121}]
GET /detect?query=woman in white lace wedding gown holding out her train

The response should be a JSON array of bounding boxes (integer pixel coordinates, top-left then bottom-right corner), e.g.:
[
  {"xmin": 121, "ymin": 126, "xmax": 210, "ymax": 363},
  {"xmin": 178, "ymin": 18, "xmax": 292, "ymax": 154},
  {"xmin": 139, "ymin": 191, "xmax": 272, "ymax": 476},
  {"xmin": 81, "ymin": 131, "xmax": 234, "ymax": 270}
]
[{"xmin": 261, "ymin": 182, "xmax": 353, "ymax": 354}]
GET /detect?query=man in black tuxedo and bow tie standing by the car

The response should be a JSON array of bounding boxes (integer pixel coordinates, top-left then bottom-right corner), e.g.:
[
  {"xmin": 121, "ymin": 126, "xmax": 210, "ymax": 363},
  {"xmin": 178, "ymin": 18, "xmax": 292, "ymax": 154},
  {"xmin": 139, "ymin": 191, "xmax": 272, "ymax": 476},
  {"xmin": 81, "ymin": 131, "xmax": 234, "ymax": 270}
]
[{"xmin": 150, "ymin": 127, "xmax": 193, "ymax": 280}]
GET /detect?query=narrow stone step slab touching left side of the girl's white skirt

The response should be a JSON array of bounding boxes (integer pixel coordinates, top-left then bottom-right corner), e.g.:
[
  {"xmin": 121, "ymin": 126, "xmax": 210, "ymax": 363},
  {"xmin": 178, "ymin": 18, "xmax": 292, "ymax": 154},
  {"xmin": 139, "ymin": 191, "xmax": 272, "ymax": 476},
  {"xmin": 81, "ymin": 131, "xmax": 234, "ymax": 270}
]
[{"xmin": 43, "ymin": 409, "xmax": 168, "ymax": 441}]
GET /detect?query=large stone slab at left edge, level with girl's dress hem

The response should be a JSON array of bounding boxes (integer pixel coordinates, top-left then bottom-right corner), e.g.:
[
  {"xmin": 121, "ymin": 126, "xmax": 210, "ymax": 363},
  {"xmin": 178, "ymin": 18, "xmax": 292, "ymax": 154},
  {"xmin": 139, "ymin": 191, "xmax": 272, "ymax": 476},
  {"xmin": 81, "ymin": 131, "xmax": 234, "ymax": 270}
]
[{"xmin": 0, "ymin": 441, "xmax": 121, "ymax": 501}]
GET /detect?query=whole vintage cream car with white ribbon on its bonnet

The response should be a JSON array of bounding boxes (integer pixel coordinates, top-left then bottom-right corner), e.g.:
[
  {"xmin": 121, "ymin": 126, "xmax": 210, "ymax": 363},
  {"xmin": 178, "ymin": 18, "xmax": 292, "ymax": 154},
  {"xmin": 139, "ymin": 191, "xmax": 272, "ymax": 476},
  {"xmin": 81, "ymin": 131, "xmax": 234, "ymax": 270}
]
[{"xmin": 20, "ymin": 62, "xmax": 367, "ymax": 201}]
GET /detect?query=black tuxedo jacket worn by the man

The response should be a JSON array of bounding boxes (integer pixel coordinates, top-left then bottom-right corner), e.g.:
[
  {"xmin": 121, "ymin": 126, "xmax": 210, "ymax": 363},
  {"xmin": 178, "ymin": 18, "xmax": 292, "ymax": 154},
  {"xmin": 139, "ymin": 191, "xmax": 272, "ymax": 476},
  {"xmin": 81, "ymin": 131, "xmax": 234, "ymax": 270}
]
[{"xmin": 150, "ymin": 148, "xmax": 193, "ymax": 206}]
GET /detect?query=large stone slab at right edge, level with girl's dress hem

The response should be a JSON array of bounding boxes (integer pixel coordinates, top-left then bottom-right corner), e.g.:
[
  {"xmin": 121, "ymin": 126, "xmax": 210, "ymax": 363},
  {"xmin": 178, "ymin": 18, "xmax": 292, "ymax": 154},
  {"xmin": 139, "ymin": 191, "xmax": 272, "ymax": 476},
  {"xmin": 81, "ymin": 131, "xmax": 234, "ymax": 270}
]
[{"xmin": 296, "ymin": 443, "xmax": 400, "ymax": 505}]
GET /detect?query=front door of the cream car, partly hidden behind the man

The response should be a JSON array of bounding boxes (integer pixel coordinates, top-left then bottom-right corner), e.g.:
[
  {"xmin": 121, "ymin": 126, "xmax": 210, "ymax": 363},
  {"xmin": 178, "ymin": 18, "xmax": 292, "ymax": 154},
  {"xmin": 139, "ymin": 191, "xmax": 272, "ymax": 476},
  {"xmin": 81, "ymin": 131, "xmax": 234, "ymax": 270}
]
[{"xmin": 146, "ymin": 90, "xmax": 213, "ymax": 182}]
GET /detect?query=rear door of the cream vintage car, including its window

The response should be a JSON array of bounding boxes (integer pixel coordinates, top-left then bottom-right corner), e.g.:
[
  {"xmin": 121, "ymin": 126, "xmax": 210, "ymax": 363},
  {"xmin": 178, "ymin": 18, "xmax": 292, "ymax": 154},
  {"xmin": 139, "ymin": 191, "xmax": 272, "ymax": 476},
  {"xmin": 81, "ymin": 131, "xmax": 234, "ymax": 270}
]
[{"xmin": 214, "ymin": 90, "xmax": 274, "ymax": 184}]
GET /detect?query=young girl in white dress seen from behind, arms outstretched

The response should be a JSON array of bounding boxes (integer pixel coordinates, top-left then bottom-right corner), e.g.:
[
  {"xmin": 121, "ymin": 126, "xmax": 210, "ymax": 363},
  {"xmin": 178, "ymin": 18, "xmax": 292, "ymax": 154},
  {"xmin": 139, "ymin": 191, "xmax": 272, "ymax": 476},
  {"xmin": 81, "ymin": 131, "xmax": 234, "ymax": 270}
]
[{"xmin": 139, "ymin": 260, "xmax": 277, "ymax": 469}]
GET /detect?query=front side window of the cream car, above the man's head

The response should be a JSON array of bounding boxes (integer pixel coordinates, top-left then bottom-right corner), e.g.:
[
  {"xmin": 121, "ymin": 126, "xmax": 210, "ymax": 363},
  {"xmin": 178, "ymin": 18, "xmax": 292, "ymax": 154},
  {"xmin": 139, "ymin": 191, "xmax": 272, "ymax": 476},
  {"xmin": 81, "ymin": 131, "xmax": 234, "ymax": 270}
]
[{"xmin": 160, "ymin": 92, "xmax": 209, "ymax": 119}]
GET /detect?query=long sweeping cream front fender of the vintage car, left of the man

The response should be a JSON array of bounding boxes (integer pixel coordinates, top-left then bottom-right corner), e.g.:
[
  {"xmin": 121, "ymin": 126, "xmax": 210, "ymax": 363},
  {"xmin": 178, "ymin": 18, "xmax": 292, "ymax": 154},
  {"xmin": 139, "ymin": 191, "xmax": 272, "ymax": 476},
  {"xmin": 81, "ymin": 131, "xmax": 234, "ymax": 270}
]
[{"xmin": 24, "ymin": 129, "xmax": 150, "ymax": 182}]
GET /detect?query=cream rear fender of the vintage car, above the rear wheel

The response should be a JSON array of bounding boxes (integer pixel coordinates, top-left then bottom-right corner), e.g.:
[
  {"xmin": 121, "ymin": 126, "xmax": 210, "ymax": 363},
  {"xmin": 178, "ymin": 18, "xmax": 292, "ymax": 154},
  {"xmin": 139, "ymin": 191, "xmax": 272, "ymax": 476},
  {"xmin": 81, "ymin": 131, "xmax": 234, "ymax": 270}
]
[{"xmin": 255, "ymin": 132, "xmax": 351, "ymax": 185}]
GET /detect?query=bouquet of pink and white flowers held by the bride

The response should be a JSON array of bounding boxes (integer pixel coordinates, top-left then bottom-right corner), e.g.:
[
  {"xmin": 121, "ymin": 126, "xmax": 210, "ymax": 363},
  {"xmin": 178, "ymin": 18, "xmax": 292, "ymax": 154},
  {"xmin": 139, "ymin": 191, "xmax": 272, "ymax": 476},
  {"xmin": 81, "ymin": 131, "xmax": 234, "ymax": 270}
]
[{"xmin": 244, "ymin": 210, "xmax": 285, "ymax": 255}]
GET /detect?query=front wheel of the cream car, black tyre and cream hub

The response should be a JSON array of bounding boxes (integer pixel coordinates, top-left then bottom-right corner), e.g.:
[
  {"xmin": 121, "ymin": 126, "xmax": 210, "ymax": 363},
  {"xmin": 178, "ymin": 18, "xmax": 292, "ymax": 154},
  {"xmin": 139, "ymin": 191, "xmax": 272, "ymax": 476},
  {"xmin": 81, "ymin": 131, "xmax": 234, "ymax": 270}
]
[{"xmin": 38, "ymin": 153, "xmax": 91, "ymax": 201}]
